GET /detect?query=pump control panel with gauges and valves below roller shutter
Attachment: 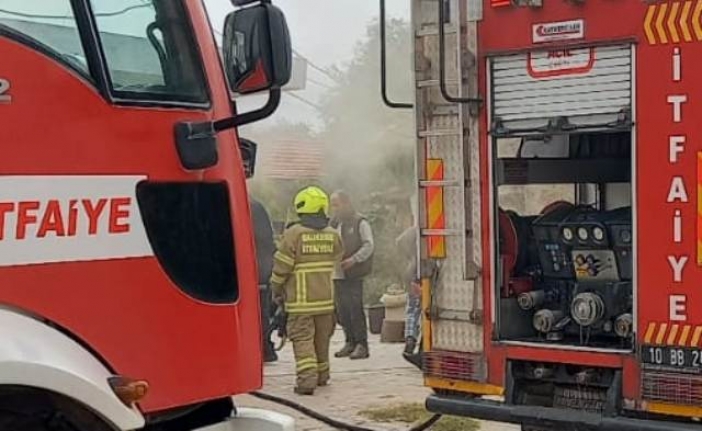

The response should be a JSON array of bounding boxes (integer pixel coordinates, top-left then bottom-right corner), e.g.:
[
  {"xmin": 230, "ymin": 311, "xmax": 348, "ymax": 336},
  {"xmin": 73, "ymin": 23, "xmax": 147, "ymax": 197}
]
[{"xmin": 499, "ymin": 202, "xmax": 633, "ymax": 346}]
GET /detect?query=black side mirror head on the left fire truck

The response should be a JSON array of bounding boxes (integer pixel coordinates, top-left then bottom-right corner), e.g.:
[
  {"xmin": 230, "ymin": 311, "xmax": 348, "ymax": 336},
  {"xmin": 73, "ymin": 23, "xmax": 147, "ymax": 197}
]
[{"xmin": 222, "ymin": 1, "xmax": 292, "ymax": 94}]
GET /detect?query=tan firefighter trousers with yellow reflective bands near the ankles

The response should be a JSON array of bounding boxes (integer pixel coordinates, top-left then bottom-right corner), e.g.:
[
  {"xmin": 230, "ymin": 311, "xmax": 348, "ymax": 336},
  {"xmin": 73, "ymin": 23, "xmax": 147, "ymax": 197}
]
[{"xmin": 287, "ymin": 313, "xmax": 336, "ymax": 389}]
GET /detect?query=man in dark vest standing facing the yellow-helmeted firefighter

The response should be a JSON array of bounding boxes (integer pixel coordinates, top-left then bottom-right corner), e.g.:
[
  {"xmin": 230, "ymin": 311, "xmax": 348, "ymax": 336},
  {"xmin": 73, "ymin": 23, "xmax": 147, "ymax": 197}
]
[{"xmin": 331, "ymin": 191, "xmax": 374, "ymax": 359}]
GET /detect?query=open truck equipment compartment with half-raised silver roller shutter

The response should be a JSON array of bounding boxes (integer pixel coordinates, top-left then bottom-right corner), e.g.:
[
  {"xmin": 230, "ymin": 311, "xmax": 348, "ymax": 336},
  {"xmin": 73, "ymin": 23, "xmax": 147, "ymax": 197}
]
[{"xmin": 490, "ymin": 44, "xmax": 635, "ymax": 351}]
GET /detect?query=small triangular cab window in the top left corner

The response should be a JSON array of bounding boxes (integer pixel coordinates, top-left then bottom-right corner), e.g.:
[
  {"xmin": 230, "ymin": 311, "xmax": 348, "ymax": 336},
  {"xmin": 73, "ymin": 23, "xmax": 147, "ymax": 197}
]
[{"xmin": 0, "ymin": 0, "xmax": 88, "ymax": 77}]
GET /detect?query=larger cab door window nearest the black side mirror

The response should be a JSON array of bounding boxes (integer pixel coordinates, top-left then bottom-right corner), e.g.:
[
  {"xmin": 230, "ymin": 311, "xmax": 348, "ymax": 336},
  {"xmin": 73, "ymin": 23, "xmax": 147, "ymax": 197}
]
[{"xmin": 90, "ymin": 0, "xmax": 208, "ymax": 104}]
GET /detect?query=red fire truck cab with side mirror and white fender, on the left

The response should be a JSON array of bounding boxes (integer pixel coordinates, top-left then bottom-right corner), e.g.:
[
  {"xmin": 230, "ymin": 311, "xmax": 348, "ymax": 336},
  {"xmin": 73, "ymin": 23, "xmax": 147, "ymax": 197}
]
[{"xmin": 0, "ymin": 0, "xmax": 293, "ymax": 431}]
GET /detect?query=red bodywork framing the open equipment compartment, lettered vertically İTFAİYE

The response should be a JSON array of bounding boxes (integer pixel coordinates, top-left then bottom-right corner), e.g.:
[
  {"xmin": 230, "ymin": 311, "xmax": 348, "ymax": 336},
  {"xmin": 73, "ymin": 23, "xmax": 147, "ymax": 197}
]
[{"xmin": 478, "ymin": 1, "xmax": 702, "ymax": 410}]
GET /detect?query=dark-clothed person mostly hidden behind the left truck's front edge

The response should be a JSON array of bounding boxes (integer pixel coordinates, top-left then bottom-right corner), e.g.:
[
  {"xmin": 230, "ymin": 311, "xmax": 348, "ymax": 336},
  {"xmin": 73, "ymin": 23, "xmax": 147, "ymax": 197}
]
[{"xmin": 249, "ymin": 197, "xmax": 278, "ymax": 362}]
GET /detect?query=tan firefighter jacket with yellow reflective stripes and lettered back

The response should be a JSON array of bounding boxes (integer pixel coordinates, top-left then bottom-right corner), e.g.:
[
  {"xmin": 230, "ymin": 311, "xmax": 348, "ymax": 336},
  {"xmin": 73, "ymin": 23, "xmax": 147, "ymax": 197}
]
[{"xmin": 271, "ymin": 223, "xmax": 343, "ymax": 315}]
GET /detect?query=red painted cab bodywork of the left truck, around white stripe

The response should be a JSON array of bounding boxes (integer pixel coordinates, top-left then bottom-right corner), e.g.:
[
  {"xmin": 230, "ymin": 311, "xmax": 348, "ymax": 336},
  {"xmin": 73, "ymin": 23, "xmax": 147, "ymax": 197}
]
[{"xmin": 0, "ymin": 0, "xmax": 262, "ymax": 413}]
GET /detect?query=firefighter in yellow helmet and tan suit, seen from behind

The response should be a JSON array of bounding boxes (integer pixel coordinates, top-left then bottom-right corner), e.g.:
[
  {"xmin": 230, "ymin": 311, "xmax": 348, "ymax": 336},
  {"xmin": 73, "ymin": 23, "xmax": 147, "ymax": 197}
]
[{"xmin": 271, "ymin": 187, "xmax": 343, "ymax": 395}]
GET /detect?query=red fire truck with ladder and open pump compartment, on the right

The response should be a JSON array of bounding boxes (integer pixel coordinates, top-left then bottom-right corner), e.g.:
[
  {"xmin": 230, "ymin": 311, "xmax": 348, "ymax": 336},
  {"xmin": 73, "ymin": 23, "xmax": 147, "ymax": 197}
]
[{"xmin": 396, "ymin": 0, "xmax": 702, "ymax": 430}]
